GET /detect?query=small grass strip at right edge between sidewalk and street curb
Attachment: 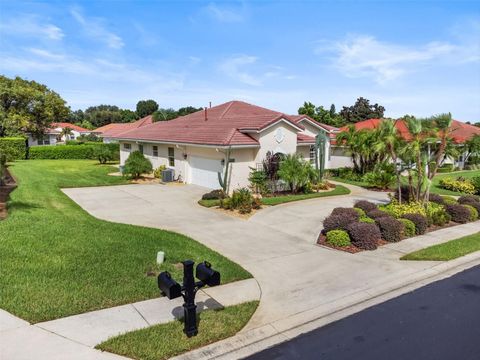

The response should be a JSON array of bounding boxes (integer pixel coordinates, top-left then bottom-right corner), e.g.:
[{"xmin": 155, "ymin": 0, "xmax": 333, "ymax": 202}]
[{"xmin": 401, "ymin": 232, "xmax": 480, "ymax": 261}]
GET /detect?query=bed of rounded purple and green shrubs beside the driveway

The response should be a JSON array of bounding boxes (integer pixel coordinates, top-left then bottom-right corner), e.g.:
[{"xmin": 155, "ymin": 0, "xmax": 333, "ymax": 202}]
[{"xmin": 317, "ymin": 195, "xmax": 480, "ymax": 253}]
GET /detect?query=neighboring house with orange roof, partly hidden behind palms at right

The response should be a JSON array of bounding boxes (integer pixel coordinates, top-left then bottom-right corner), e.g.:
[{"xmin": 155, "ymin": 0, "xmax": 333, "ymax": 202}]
[{"xmin": 331, "ymin": 119, "xmax": 480, "ymax": 168}]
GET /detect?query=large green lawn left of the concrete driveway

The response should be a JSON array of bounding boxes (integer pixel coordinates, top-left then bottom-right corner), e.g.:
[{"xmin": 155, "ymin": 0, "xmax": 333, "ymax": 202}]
[{"xmin": 0, "ymin": 160, "xmax": 251, "ymax": 322}]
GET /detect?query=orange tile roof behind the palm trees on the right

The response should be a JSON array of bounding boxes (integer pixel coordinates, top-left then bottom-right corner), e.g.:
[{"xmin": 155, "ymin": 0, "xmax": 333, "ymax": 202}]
[{"xmin": 340, "ymin": 119, "xmax": 480, "ymax": 143}]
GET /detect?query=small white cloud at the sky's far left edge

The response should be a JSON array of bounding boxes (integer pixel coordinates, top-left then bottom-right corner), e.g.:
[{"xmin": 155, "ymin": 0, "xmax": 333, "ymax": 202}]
[{"xmin": 0, "ymin": 14, "xmax": 65, "ymax": 40}]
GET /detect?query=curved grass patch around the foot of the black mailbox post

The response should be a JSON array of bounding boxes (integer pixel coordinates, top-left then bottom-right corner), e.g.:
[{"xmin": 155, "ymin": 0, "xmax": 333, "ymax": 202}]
[{"xmin": 96, "ymin": 301, "xmax": 258, "ymax": 360}]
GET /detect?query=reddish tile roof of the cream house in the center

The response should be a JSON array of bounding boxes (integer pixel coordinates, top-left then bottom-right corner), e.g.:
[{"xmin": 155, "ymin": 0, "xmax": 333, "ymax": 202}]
[{"xmin": 113, "ymin": 101, "xmax": 338, "ymax": 146}]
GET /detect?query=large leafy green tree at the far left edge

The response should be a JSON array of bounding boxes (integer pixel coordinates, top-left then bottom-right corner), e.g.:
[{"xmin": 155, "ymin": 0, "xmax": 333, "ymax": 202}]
[{"xmin": 0, "ymin": 76, "xmax": 69, "ymax": 137}]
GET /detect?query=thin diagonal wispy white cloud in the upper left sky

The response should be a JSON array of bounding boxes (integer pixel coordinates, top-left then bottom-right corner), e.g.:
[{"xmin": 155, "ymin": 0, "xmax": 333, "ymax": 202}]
[{"xmin": 70, "ymin": 7, "xmax": 125, "ymax": 49}]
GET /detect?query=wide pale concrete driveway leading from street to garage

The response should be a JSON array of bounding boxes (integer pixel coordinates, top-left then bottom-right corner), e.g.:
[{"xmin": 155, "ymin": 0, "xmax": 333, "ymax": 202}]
[{"xmin": 63, "ymin": 184, "xmax": 458, "ymax": 329}]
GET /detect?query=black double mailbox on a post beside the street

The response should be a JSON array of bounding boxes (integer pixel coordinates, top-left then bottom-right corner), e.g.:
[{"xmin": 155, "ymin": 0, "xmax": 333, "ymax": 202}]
[{"xmin": 158, "ymin": 260, "xmax": 220, "ymax": 337}]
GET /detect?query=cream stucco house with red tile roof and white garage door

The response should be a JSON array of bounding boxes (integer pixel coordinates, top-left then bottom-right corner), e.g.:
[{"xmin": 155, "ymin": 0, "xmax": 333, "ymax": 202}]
[{"xmin": 112, "ymin": 101, "xmax": 338, "ymax": 190}]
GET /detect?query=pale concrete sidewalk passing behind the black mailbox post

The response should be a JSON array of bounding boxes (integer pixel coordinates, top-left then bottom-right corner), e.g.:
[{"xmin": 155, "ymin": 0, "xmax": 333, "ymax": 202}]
[{"xmin": 0, "ymin": 279, "xmax": 260, "ymax": 360}]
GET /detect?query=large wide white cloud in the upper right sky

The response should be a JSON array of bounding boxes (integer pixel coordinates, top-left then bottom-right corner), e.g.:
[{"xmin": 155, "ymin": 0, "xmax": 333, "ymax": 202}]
[{"xmin": 316, "ymin": 35, "xmax": 478, "ymax": 84}]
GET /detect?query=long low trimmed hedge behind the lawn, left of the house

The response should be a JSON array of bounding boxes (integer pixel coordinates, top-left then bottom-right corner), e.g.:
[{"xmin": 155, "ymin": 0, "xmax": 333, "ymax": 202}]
[{"xmin": 29, "ymin": 144, "xmax": 119, "ymax": 159}]
